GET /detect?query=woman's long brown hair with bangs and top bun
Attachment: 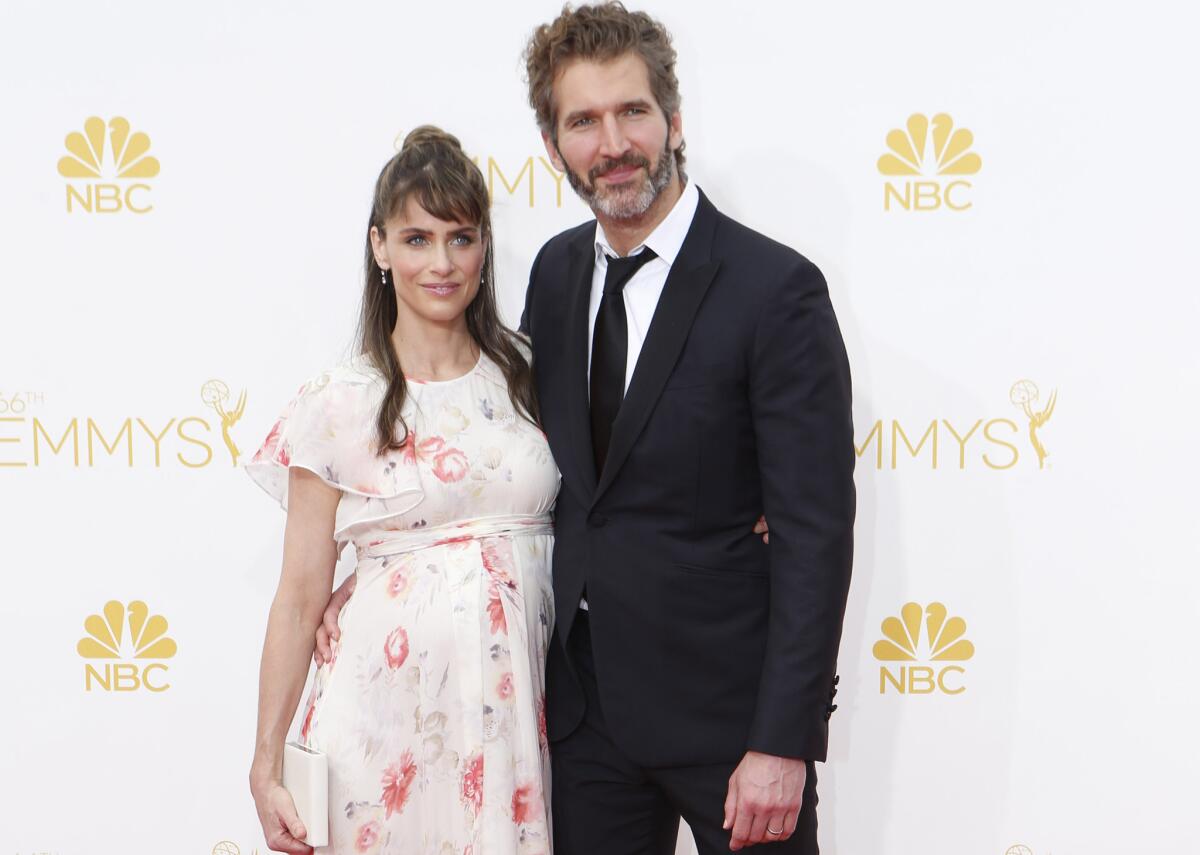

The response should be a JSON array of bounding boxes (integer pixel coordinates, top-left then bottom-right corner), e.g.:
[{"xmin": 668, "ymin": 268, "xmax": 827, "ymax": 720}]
[{"xmin": 358, "ymin": 125, "xmax": 538, "ymax": 454}]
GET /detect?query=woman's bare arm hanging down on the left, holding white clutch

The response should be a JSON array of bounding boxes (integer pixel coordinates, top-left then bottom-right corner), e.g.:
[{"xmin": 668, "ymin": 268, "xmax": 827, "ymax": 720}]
[{"xmin": 250, "ymin": 467, "xmax": 341, "ymax": 853}]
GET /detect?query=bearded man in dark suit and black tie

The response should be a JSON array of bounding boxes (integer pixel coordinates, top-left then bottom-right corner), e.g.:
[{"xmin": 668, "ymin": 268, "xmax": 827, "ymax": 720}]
[{"xmin": 326, "ymin": 2, "xmax": 854, "ymax": 855}]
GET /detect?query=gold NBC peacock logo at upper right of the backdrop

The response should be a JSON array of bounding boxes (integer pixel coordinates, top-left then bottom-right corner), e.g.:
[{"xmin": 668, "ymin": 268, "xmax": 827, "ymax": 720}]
[{"xmin": 877, "ymin": 113, "xmax": 983, "ymax": 211}]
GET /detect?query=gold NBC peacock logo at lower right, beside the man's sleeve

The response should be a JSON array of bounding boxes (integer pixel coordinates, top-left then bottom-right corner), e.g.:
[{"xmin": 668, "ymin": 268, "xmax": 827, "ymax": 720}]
[{"xmin": 871, "ymin": 603, "xmax": 974, "ymax": 695}]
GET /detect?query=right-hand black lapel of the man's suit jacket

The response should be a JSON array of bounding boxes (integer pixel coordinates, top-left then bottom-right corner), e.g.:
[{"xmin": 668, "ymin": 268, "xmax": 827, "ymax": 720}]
[{"xmin": 583, "ymin": 193, "xmax": 721, "ymax": 506}]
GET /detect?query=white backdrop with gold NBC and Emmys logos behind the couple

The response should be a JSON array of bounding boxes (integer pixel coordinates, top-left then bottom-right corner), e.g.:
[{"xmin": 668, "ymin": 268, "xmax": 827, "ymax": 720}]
[{"xmin": 0, "ymin": 0, "xmax": 1200, "ymax": 855}]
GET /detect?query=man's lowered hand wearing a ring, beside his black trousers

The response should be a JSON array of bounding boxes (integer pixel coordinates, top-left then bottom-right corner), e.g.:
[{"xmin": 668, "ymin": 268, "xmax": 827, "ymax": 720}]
[{"xmin": 721, "ymin": 751, "xmax": 808, "ymax": 851}]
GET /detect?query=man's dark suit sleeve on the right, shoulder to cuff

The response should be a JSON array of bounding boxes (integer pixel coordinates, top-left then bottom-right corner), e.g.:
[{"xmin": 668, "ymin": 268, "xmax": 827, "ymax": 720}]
[{"xmin": 748, "ymin": 261, "xmax": 854, "ymax": 760}]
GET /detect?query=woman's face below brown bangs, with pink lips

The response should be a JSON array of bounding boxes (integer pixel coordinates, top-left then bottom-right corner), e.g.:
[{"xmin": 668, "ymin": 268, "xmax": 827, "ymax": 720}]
[{"xmin": 371, "ymin": 197, "xmax": 486, "ymax": 327}]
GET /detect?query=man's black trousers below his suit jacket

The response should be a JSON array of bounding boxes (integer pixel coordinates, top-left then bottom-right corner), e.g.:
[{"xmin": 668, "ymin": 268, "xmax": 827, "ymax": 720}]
[{"xmin": 551, "ymin": 611, "xmax": 817, "ymax": 855}]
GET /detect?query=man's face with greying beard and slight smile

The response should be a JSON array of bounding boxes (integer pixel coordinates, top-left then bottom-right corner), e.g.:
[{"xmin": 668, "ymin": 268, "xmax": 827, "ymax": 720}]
[{"xmin": 542, "ymin": 53, "xmax": 683, "ymax": 220}]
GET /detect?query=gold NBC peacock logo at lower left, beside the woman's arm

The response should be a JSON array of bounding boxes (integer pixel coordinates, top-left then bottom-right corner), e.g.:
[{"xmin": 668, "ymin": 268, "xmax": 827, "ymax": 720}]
[{"xmin": 76, "ymin": 599, "xmax": 178, "ymax": 692}]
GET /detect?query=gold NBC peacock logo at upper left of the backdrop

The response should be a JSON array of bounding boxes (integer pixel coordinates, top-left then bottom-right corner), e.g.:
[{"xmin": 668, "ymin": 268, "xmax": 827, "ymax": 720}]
[{"xmin": 59, "ymin": 115, "xmax": 160, "ymax": 214}]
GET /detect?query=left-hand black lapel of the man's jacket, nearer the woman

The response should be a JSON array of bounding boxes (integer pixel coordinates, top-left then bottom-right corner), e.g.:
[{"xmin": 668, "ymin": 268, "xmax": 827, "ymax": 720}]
[{"xmin": 559, "ymin": 229, "xmax": 596, "ymax": 506}]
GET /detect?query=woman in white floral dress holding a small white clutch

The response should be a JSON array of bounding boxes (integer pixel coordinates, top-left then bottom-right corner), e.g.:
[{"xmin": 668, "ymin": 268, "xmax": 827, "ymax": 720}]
[{"xmin": 247, "ymin": 127, "xmax": 558, "ymax": 855}]
